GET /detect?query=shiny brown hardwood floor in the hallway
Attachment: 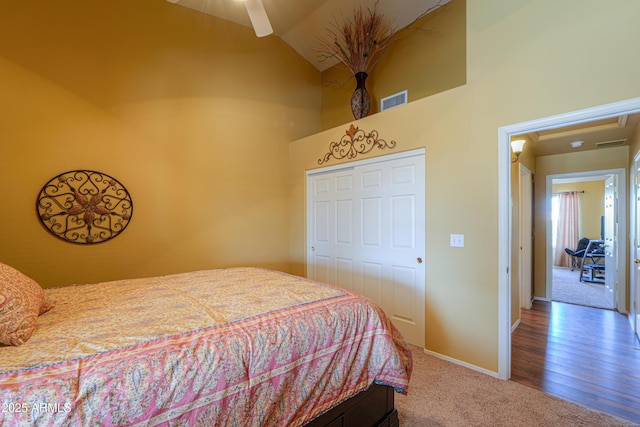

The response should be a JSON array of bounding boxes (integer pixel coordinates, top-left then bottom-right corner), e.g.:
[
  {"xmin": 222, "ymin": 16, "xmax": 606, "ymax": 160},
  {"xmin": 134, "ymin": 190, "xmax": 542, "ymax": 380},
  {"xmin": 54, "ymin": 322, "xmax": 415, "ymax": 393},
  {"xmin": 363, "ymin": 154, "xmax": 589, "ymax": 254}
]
[{"xmin": 511, "ymin": 301, "xmax": 640, "ymax": 424}]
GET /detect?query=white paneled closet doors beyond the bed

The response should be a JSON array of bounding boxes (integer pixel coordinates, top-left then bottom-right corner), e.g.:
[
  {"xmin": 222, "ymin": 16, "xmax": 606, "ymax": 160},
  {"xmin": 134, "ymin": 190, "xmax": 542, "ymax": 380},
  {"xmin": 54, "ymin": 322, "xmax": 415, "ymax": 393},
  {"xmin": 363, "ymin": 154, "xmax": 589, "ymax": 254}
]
[{"xmin": 307, "ymin": 150, "xmax": 426, "ymax": 347}]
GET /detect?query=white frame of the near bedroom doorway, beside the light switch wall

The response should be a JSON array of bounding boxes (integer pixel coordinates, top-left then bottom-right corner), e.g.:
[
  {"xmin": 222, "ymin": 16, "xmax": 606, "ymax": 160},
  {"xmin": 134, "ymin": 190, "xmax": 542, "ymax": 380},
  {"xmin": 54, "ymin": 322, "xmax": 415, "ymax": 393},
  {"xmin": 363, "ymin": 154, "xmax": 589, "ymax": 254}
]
[{"xmin": 498, "ymin": 98, "xmax": 640, "ymax": 379}]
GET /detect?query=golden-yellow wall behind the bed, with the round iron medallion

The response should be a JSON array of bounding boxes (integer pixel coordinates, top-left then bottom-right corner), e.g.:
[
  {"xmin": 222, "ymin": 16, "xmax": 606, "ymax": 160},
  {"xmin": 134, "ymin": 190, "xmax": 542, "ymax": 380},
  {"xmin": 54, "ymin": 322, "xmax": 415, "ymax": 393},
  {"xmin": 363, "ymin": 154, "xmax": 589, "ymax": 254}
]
[{"xmin": 0, "ymin": 0, "xmax": 321, "ymax": 286}]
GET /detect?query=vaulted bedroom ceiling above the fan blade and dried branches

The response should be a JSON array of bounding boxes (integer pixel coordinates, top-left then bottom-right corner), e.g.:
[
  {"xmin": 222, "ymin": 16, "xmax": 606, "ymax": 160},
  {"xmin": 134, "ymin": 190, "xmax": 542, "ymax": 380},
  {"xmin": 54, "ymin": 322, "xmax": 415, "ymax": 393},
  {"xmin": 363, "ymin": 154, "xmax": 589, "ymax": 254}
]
[{"xmin": 169, "ymin": 0, "xmax": 450, "ymax": 71}]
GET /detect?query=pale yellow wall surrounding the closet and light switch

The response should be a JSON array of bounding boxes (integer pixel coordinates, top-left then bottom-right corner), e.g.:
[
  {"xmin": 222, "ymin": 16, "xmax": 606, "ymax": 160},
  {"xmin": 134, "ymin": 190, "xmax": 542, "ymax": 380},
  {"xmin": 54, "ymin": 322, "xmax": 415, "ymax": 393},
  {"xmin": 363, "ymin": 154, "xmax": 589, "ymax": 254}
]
[{"xmin": 290, "ymin": 0, "xmax": 640, "ymax": 371}]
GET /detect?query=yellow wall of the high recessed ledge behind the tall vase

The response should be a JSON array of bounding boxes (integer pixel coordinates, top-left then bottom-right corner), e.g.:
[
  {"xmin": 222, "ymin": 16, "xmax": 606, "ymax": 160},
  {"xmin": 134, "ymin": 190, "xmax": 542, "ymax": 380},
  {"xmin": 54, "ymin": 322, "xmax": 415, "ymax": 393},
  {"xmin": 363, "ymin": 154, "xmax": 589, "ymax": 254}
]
[{"xmin": 321, "ymin": 0, "xmax": 467, "ymax": 129}]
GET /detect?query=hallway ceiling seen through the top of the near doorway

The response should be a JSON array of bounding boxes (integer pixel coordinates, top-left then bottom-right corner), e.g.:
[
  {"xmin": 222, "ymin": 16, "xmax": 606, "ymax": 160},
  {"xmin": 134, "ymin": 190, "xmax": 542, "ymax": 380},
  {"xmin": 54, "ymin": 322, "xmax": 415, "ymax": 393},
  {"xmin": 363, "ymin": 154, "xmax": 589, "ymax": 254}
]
[{"xmin": 513, "ymin": 113, "xmax": 640, "ymax": 157}]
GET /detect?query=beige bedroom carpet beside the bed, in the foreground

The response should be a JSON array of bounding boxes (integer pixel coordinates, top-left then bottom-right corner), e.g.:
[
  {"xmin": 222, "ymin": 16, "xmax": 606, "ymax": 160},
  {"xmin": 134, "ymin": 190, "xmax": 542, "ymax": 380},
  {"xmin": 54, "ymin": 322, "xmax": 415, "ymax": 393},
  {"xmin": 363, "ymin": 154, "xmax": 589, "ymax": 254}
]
[{"xmin": 396, "ymin": 346, "xmax": 638, "ymax": 427}]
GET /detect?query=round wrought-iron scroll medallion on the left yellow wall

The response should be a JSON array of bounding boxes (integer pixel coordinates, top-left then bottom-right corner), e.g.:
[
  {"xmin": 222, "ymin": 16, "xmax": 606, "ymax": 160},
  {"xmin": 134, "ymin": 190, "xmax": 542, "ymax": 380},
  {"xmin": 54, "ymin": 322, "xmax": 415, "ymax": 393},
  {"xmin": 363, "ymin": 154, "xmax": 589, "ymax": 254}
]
[{"xmin": 36, "ymin": 170, "xmax": 133, "ymax": 243}]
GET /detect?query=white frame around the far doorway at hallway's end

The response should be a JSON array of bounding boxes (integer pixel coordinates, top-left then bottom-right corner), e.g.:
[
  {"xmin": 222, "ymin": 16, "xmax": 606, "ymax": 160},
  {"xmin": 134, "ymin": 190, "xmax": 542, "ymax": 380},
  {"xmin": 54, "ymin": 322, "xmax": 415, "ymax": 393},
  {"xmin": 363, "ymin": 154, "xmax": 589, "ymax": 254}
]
[{"xmin": 545, "ymin": 168, "xmax": 627, "ymax": 313}]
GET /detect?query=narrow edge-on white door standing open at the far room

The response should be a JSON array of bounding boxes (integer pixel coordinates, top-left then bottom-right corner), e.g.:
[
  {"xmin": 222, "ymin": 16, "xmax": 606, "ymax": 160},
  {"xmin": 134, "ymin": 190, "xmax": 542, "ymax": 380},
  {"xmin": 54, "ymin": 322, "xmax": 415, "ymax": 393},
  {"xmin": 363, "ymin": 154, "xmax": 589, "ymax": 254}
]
[{"xmin": 604, "ymin": 176, "xmax": 618, "ymax": 308}]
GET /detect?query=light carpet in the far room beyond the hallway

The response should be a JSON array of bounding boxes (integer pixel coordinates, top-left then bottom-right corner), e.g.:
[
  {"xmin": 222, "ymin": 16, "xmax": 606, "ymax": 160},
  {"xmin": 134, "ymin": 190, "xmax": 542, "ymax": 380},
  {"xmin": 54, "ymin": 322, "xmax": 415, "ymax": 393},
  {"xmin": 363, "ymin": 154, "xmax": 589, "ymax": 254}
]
[{"xmin": 552, "ymin": 267, "xmax": 613, "ymax": 309}]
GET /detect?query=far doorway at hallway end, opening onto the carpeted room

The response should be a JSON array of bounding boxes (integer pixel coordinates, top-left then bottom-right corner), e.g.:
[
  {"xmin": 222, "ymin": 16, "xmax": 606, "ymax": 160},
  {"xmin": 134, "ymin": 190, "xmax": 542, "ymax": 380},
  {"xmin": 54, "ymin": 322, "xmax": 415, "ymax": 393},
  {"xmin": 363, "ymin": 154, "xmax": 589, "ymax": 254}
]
[{"xmin": 546, "ymin": 169, "xmax": 627, "ymax": 312}]
